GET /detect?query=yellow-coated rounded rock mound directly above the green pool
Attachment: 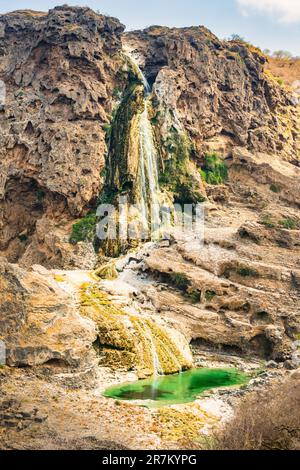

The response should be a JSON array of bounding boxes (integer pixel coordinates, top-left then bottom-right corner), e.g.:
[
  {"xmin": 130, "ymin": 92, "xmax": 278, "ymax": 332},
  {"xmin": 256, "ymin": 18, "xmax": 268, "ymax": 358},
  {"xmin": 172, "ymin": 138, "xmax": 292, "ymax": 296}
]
[{"xmin": 80, "ymin": 283, "xmax": 191, "ymax": 377}]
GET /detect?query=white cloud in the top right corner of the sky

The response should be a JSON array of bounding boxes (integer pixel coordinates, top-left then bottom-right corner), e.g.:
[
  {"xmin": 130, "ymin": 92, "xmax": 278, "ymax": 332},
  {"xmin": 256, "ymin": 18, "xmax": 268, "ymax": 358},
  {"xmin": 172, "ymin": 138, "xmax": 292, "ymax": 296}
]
[{"xmin": 237, "ymin": 0, "xmax": 300, "ymax": 23}]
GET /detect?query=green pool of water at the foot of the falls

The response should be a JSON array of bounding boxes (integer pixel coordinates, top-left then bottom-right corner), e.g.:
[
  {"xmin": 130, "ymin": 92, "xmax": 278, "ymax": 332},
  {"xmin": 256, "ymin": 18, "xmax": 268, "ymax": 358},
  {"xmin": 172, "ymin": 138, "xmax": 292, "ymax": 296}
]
[{"xmin": 104, "ymin": 369, "xmax": 249, "ymax": 406}]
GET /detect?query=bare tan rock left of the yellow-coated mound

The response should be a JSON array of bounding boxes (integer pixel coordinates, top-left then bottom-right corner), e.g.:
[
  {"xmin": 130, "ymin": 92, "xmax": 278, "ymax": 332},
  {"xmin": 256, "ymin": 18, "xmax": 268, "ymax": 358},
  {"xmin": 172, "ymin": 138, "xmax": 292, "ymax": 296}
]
[{"xmin": 0, "ymin": 258, "xmax": 96, "ymax": 367}]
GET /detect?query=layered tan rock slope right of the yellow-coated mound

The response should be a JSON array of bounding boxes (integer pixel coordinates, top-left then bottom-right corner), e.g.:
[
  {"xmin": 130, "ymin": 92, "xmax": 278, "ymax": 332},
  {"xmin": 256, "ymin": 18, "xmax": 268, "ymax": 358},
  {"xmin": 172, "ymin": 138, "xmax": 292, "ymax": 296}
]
[{"xmin": 139, "ymin": 224, "xmax": 299, "ymax": 362}]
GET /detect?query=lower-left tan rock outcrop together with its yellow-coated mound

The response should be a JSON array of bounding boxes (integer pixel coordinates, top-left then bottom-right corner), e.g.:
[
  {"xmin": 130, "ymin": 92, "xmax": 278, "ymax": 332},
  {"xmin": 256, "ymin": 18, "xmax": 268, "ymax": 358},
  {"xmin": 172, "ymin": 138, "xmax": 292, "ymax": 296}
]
[{"xmin": 0, "ymin": 258, "xmax": 193, "ymax": 376}]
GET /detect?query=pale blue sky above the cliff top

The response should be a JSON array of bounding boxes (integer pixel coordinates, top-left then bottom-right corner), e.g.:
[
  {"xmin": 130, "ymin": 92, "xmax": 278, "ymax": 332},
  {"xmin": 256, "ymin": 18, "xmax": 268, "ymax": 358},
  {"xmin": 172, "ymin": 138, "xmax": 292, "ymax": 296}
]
[{"xmin": 0, "ymin": 0, "xmax": 300, "ymax": 55}]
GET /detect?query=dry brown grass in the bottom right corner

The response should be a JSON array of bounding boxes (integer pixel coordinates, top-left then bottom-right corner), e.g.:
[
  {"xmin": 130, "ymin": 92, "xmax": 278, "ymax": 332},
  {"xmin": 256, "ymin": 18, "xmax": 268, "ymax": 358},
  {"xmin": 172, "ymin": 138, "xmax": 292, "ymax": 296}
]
[{"xmin": 211, "ymin": 372, "xmax": 300, "ymax": 450}]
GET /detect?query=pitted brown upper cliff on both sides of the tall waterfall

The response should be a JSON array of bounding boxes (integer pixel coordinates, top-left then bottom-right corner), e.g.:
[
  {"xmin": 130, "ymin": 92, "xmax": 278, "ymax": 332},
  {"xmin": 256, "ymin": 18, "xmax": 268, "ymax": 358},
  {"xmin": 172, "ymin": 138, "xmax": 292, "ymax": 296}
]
[{"xmin": 0, "ymin": 7, "xmax": 299, "ymax": 267}]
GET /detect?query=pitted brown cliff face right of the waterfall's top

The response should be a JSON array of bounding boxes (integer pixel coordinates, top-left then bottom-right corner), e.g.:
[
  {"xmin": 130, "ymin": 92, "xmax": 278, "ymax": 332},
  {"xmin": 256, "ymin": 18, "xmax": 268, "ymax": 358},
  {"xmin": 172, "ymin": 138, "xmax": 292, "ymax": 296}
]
[{"xmin": 123, "ymin": 26, "xmax": 299, "ymax": 157}]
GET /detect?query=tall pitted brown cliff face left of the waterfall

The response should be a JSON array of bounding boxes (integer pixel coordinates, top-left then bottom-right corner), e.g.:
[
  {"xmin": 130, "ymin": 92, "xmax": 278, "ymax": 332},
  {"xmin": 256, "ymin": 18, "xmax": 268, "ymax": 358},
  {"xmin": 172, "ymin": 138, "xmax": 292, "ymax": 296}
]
[{"xmin": 0, "ymin": 7, "xmax": 124, "ymax": 264}]
